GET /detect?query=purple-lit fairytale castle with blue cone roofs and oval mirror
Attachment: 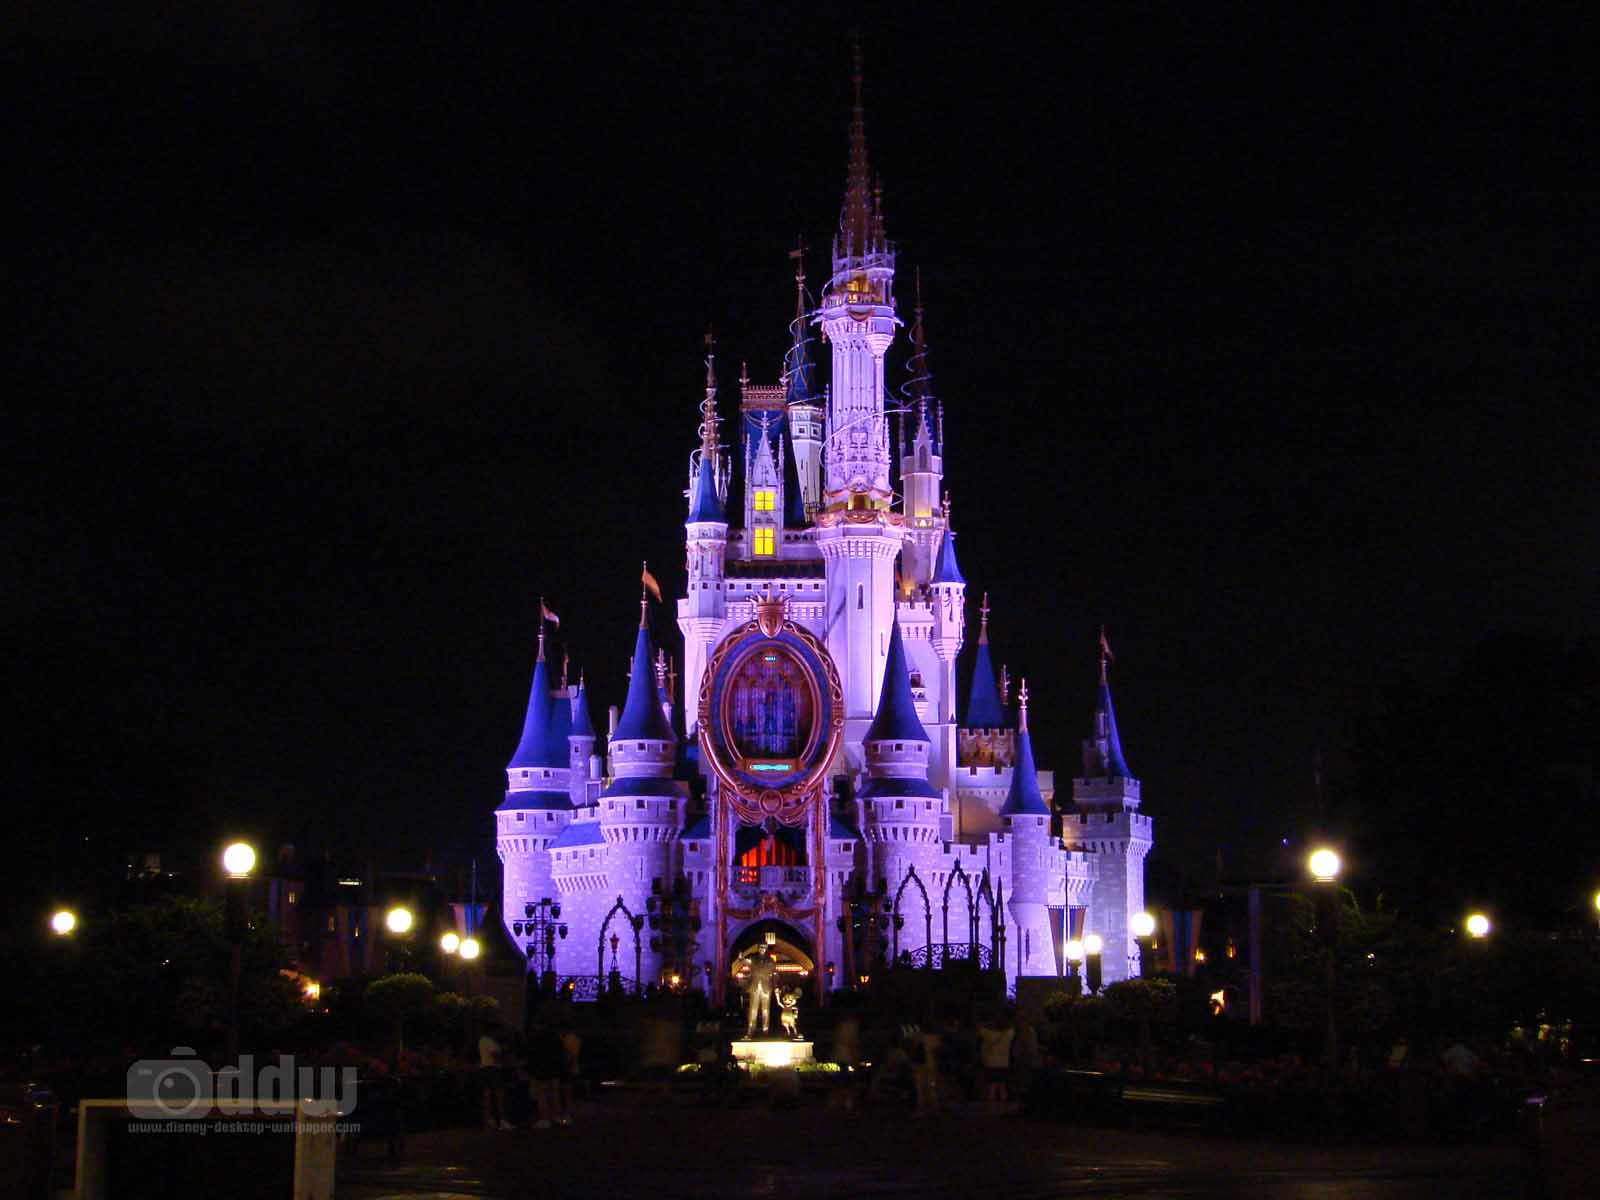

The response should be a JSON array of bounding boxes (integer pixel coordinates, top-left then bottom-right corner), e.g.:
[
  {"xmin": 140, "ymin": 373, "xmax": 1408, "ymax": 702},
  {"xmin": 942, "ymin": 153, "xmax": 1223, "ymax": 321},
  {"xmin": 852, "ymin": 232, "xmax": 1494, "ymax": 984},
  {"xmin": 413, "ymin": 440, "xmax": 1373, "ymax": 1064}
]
[{"xmin": 494, "ymin": 64, "xmax": 1150, "ymax": 998}]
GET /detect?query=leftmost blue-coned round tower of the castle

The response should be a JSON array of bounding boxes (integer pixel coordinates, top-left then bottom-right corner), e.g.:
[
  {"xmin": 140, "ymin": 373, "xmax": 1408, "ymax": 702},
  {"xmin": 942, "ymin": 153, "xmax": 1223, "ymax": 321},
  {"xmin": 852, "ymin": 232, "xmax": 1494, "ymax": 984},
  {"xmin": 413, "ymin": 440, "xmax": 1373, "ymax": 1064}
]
[{"xmin": 494, "ymin": 620, "xmax": 573, "ymax": 936}]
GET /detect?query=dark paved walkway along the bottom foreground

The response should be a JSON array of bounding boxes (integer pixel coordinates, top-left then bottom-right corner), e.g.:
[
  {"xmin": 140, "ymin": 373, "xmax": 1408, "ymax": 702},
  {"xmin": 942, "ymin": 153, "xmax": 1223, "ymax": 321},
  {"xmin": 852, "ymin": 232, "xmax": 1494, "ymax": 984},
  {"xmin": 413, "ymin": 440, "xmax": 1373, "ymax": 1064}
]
[{"xmin": 338, "ymin": 1104, "xmax": 1530, "ymax": 1200}]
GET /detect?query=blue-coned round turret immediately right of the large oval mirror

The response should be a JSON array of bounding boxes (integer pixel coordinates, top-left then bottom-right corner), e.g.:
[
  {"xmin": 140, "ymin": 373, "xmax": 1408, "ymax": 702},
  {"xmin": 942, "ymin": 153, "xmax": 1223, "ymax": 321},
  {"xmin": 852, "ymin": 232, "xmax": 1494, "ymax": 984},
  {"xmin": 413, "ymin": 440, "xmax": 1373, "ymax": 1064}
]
[{"xmin": 861, "ymin": 621, "xmax": 944, "ymax": 950}]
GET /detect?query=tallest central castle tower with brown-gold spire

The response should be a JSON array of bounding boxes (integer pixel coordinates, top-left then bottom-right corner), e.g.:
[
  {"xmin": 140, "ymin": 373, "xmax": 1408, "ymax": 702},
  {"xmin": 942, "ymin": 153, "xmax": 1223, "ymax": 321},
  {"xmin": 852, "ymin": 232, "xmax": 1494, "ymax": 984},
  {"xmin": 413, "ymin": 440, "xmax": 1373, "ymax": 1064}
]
[{"xmin": 816, "ymin": 48, "xmax": 906, "ymax": 748}]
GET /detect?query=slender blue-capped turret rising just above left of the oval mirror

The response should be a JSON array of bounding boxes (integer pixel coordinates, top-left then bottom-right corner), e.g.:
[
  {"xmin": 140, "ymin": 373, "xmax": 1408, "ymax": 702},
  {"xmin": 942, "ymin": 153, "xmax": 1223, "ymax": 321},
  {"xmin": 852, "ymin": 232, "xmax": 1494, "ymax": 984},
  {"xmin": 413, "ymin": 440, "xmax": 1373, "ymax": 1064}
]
[{"xmin": 678, "ymin": 347, "xmax": 728, "ymax": 733}]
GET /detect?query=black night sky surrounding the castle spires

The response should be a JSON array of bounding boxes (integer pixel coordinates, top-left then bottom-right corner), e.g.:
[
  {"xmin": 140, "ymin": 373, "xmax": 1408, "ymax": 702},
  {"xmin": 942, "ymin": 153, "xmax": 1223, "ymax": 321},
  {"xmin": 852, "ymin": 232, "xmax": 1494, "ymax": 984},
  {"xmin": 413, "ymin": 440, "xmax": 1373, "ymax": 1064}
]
[{"xmin": 0, "ymin": 3, "xmax": 1600, "ymax": 902}]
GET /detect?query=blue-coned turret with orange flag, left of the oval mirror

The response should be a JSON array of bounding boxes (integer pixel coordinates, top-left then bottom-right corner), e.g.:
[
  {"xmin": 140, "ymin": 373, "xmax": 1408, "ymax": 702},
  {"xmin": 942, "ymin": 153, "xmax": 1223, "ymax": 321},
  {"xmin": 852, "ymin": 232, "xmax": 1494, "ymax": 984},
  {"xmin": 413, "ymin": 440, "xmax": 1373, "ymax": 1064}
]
[{"xmin": 595, "ymin": 597, "xmax": 688, "ymax": 984}]
